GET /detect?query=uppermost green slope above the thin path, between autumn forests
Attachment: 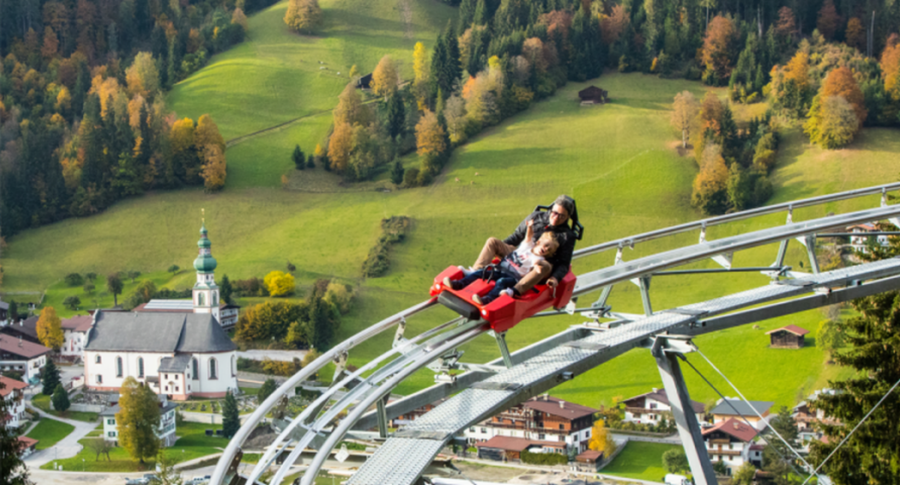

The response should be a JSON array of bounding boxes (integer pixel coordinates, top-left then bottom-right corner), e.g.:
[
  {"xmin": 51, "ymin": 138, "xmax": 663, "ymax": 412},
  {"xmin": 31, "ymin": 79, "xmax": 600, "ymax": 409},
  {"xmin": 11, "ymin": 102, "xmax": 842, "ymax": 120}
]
[{"xmin": 169, "ymin": 0, "xmax": 455, "ymax": 140}]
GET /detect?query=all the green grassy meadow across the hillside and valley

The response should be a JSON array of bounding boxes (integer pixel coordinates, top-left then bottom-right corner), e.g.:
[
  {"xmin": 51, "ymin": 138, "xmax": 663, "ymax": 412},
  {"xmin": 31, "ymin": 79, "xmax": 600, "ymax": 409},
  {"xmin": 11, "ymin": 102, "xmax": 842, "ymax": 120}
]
[{"xmin": 3, "ymin": 0, "xmax": 900, "ymax": 412}]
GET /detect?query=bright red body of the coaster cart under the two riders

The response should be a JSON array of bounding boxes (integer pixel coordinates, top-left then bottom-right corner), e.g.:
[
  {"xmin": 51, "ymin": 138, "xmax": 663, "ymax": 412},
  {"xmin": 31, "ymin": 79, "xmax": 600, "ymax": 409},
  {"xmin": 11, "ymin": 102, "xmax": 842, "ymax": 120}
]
[{"xmin": 430, "ymin": 266, "xmax": 575, "ymax": 332}]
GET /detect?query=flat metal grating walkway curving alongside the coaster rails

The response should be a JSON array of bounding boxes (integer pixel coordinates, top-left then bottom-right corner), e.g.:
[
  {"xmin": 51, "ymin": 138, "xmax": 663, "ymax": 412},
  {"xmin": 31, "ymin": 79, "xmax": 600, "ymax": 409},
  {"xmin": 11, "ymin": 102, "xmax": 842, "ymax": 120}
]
[{"xmin": 347, "ymin": 258, "xmax": 900, "ymax": 485}]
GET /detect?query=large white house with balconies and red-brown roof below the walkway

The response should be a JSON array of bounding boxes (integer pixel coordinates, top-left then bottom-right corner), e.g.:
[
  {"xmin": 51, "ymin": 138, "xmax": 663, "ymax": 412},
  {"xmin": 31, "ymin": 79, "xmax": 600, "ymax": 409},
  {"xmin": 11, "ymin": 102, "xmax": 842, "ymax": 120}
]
[{"xmin": 465, "ymin": 394, "xmax": 599, "ymax": 453}]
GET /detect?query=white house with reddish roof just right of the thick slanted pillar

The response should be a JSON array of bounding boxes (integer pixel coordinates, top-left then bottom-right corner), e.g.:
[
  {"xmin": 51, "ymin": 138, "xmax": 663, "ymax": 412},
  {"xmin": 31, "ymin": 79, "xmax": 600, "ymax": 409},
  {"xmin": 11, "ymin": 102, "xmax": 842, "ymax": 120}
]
[{"xmin": 703, "ymin": 418, "xmax": 762, "ymax": 475}]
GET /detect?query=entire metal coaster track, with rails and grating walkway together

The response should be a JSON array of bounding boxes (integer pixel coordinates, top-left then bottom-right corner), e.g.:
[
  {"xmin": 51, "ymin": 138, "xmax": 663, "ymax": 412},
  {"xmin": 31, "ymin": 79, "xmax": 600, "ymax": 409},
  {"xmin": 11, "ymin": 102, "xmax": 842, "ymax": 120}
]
[{"xmin": 211, "ymin": 183, "xmax": 900, "ymax": 485}]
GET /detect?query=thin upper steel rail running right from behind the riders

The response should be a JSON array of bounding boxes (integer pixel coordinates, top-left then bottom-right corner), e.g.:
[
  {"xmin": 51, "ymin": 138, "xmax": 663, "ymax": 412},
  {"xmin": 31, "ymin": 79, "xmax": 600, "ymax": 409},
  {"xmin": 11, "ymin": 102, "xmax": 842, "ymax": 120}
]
[{"xmin": 572, "ymin": 182, "xmax": 900, "ymax": 259}]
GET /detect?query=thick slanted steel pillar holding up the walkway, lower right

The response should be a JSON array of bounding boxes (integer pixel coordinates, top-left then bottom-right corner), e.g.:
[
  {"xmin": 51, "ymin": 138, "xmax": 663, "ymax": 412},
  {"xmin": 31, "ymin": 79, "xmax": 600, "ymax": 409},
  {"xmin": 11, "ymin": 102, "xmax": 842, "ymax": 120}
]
[{"xmin": 651, "ymin": 337, "xmax": 718, "ymax": 485}]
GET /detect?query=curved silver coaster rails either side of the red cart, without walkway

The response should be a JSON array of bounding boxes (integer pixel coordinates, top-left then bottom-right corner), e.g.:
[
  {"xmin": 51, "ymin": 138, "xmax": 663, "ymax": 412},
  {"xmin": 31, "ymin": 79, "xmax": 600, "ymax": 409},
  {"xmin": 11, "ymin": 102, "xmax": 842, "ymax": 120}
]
[{"xmin": 211, "ymin": 183, "xmax": 900, "ymax": 485}]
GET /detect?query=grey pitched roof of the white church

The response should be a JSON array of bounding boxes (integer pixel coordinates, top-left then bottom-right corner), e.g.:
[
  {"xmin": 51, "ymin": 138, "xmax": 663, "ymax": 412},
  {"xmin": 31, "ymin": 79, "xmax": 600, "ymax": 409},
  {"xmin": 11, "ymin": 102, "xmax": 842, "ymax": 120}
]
[{"xmin": 85, "ymin": 312, "xmax": 237, "ymax": 353}]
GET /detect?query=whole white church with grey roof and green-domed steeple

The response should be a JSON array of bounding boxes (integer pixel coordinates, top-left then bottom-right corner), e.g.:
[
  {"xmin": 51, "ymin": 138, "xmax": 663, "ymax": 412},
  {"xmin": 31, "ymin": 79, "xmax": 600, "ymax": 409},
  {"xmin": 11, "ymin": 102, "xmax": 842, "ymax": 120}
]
[{"xmin": 84, "ymin": 225, "xmax": 238, "ymax": 401}]
